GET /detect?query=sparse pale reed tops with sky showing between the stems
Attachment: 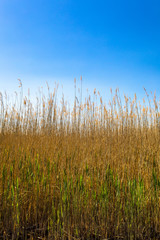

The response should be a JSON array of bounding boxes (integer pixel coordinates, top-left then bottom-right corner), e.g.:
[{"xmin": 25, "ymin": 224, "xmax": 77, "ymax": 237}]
[{"xmin": 0, "ymin": 79, "xmax": 160, "ymax": 134}]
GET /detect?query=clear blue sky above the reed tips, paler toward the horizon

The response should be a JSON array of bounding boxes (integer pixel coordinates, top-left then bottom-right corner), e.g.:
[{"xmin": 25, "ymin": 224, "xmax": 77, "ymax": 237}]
[{"xmin": 0, "ymin": 0, "xmax": 160, "ymax": 104}]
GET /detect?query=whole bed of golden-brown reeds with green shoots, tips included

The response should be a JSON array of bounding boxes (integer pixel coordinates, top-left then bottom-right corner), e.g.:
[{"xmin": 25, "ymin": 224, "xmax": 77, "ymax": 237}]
[{"xmin": 0, "ymin": 79, "xmax": 160, "ymax": 240}]
